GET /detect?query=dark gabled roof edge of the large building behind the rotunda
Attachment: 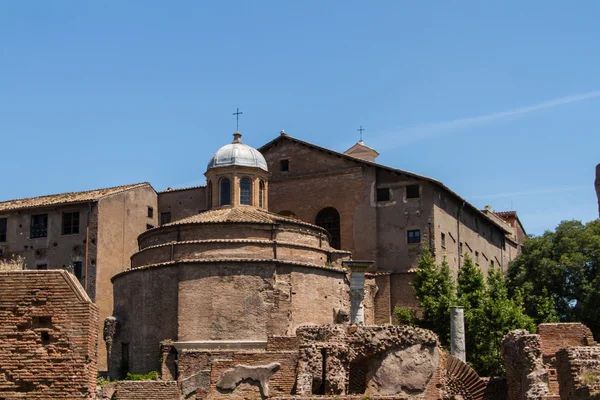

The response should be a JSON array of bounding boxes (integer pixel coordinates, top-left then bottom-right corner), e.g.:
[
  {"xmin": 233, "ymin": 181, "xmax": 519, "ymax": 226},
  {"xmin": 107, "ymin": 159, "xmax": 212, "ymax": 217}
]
[{"xmin": 258, "ymin": 133, "xmax": 511, "ymax": 233}]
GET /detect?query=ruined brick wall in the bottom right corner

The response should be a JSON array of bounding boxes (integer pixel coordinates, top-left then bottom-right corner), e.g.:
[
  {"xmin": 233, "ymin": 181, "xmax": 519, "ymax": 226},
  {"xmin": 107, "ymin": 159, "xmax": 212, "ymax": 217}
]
[{"xmin": 556, "ymin": 346, "xmax": 600, "ymax": 400}]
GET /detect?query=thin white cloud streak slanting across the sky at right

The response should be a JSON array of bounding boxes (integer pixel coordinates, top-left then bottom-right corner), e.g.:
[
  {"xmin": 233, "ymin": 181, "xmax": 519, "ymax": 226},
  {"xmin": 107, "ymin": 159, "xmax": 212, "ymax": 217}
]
[{"xmin": 374, "ymin": 90, "xmax": 600, "ymax": 148}]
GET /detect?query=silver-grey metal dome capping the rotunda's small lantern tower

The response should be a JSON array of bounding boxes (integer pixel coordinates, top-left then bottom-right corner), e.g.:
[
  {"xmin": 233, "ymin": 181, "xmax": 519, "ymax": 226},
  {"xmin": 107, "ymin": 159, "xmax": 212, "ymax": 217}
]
[{"xmin": 206, "ymin": 132, "xmax": 269, "ymax": 172}]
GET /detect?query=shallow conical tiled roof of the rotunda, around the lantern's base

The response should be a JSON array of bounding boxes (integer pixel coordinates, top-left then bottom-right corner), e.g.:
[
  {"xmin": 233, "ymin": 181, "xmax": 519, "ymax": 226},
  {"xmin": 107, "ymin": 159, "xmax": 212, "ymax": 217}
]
[{"xmin": 159, "ymin": 206, "xmax": 323, "ymax": 230}]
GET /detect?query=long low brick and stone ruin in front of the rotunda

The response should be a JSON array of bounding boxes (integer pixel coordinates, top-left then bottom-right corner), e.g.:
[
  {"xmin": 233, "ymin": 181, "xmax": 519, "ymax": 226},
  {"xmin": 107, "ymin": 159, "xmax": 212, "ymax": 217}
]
[{"xmin": 101, "ymin": 324, "xmax": 485, "ymax": 400}]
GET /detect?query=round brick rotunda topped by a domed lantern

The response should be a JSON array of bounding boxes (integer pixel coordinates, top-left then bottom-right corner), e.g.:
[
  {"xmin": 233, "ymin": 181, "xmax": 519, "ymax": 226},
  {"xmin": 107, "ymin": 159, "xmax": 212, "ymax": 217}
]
[{"xmin": 109, "ymin": 132, "xmax": 350, "ymax": 378}]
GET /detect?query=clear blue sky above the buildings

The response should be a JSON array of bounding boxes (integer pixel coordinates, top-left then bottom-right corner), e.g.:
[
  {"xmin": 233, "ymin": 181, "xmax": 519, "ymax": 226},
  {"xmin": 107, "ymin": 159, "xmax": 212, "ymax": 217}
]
[{"xmin": 0, "ymin": 0, "xmax": 600, "ymax": 234}]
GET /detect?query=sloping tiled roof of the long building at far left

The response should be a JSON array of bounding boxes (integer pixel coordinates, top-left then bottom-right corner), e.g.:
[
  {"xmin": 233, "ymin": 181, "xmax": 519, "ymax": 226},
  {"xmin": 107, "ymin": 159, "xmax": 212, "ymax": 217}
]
[{"xmin": 0, "ymin": 182, "xmax": 152, "ymax": 212}]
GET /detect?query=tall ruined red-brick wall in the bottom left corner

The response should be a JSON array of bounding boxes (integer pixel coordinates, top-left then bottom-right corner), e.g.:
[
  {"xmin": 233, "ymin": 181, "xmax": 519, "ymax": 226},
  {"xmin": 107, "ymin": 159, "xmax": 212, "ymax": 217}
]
[{"xmin": 0, "ymin": 270, "xmax": 98, "ymax": 399}]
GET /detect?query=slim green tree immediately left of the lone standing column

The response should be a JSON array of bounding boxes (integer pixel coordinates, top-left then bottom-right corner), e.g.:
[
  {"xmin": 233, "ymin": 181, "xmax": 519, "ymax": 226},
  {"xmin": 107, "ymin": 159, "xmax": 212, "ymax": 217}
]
[{"xmin": 413, "ymin": 245, "xmax": 456, "ymax": 345}]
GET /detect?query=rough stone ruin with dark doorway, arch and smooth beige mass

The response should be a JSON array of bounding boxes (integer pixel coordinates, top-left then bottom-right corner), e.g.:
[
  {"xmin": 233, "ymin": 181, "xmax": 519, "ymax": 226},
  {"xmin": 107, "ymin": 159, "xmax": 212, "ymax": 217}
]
[{"xmin": 296, "ymin": 325, "xmax": 439, "ymax": 395}]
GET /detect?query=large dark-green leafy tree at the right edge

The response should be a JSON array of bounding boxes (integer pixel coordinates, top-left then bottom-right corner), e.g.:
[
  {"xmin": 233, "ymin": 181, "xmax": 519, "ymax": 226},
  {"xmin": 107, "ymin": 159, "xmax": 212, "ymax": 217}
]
[{"xmin": 508, "ymin": 220, "xmax": 600, "ymax": 338}]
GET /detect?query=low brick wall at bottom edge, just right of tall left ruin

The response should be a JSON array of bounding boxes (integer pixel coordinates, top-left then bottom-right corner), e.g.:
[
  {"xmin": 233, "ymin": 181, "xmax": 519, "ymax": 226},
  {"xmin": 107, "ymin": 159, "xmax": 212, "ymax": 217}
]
[{"xmin": 101, "ymin": 381, "xmax": 179, "ymax": 400}]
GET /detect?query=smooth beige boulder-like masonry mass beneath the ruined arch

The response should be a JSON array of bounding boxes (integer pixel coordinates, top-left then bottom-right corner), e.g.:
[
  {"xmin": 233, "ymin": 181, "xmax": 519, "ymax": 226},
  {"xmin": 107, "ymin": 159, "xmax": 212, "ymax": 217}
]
[{"xmin": 367, "ymin": 344, "xmax": 439, "ymax": 396}]
